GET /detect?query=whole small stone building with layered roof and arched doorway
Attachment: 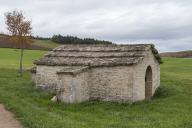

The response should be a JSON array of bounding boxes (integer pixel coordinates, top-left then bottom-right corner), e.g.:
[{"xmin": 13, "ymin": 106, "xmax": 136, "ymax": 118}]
[{"xmin": 32, "ymin": 44, "xmax": 161, "ymax": 103}]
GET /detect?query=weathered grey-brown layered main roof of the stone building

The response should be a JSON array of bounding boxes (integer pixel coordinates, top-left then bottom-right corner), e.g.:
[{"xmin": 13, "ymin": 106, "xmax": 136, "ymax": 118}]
[{"xmin": 34, "ymin": 44, "xmax": 161, "ymax": 67}]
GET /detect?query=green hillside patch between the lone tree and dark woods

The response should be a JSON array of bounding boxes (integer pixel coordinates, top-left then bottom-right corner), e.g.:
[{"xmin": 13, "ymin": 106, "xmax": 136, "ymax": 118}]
[{"xmin": 32, "ymin": 40, "xmax": 59, "ymax": 49}]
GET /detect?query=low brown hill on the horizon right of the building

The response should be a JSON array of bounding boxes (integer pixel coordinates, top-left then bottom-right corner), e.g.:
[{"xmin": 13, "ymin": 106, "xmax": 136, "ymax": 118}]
[{"xmin": 161, "ymin": 50, "xmax": 192, "ymax": 58}]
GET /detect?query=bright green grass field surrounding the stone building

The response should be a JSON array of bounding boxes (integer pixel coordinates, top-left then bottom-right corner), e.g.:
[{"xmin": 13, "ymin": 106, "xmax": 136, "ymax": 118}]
[{"xmin": 0, "ymin": 49, "xmax": 192, "ymax": 128}]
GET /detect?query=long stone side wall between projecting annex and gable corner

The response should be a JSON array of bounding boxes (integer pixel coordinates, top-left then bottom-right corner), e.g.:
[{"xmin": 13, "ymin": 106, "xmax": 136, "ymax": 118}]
[{"xmin": 89, "ymin": 66, "xmax": 133, "ymax": 102}]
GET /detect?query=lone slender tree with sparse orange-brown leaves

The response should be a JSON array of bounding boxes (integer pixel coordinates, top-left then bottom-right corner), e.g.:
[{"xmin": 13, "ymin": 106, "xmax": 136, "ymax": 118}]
[{"xmin": 5, "ymin": 10, "xmax": 32, "ymax": 76}]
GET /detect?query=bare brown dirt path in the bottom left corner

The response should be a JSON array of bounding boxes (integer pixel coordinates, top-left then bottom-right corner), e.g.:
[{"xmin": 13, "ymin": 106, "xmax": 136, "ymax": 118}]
[{"xmin": 0, "ymin": 104, "xmax": 22, "ymax": 128}]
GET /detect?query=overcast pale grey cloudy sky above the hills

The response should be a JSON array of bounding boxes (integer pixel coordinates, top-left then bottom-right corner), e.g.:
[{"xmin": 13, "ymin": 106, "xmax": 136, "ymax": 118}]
[{"xmin": 0, "ymin": 0, "xmax": 192, "ymax": 52}]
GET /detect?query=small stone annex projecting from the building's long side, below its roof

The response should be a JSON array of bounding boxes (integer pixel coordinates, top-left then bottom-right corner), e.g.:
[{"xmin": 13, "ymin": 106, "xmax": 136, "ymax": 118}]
[{"xmin": 57, "ymin": 72, "xmax": 89, "ymax": 103}]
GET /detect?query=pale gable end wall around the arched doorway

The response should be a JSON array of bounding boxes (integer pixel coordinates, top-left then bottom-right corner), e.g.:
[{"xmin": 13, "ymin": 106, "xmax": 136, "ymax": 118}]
[{"xmin": 133, "ymin": 50, "xmax": 160, "ymax": 102}]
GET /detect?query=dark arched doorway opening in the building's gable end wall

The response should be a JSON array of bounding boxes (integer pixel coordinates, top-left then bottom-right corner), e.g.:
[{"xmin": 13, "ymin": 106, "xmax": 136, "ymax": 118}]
[{"xmin": 145, "ymin": 66, "xmax": 153, "ymax": 100}]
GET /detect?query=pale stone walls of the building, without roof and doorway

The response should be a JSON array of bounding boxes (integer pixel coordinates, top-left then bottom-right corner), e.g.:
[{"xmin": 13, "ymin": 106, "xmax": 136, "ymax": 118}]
[{"xmin": 33, "ymin": 50, "xmax": 160, "ymax": 103}]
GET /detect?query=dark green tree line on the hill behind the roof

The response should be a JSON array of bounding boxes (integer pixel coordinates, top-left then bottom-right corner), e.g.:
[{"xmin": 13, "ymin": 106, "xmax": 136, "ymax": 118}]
[{"xmin": 51, "ymin": 34, "xmax": 112, "ymax": 44}]
